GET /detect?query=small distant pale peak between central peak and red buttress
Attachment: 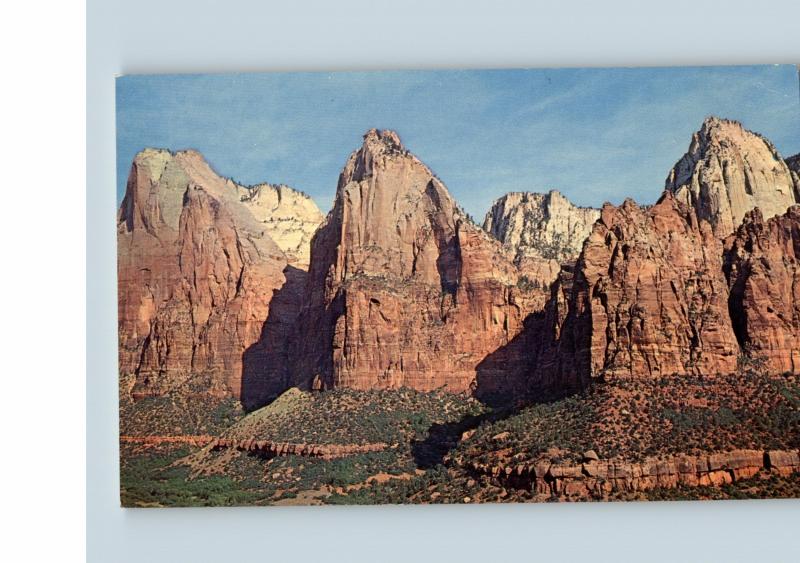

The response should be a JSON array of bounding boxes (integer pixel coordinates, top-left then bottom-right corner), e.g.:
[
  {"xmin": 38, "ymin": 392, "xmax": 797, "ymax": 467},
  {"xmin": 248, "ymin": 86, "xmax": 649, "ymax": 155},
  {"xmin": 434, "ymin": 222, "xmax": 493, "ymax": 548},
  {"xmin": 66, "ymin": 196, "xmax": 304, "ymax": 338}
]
[{"xmin": 483, "ymin": 191, "xmax": 600, "ymax": 286}]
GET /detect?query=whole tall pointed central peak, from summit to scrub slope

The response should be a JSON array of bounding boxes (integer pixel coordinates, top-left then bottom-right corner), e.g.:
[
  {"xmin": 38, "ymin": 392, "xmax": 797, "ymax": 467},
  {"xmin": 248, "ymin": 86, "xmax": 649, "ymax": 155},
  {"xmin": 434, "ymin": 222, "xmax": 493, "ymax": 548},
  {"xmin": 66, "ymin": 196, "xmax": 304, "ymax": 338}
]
[{"xmin": 292, "ymin": 129, "xmax": 544, "ymax": 398}]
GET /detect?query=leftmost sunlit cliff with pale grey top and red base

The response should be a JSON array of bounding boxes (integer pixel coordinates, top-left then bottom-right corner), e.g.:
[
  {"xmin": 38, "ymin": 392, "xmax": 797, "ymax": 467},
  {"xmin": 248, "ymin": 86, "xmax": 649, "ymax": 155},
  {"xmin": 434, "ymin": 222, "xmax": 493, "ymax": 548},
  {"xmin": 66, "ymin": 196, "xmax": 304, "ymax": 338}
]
[{"xmin": 117, "ymin": 149, "xmax": 314, "ymax": 404}]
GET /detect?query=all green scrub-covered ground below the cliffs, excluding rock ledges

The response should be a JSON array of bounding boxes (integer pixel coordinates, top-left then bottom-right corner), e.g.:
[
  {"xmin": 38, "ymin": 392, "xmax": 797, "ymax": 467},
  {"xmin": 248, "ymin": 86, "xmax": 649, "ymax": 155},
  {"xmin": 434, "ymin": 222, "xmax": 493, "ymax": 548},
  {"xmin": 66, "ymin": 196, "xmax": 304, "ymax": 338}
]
[{"xmin": 121, "ymin": 372, "xmax": 800, "ymax": 506}]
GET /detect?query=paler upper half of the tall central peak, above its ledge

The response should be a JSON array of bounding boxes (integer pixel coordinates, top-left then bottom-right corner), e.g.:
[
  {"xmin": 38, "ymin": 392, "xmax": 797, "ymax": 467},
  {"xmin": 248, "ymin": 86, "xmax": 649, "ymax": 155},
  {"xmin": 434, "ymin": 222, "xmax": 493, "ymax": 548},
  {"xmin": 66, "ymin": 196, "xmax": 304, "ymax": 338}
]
[{"xmin": 312, "ymin": 129, "xmax": 477, "ymax": 283}]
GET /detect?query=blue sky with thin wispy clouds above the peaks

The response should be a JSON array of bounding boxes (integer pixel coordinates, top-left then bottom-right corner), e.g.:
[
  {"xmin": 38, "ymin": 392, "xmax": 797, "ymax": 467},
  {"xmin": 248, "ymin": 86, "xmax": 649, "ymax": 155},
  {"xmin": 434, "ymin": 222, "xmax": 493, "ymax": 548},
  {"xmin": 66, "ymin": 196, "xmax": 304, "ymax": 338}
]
[{"xmin": 117, "ymin": 65, "xmax": 800, "ymax": 219}]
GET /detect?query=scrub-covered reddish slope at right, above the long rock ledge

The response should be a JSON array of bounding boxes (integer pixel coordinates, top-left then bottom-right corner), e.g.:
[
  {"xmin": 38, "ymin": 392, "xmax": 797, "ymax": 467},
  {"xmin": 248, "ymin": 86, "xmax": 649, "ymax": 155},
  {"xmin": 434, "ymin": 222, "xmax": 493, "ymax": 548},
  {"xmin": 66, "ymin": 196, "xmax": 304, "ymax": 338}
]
[{"xmin": 454, "ymin": 373, "xmax": 800, "ymax": 468}]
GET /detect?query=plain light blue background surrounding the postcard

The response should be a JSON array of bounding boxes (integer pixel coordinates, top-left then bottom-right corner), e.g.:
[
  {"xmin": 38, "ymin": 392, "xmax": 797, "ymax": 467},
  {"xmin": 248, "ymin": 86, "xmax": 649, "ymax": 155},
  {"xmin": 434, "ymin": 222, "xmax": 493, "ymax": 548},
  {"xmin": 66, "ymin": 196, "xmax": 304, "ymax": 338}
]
[{"xmin": 89, "ymin": 0, "xmax": 800, "ymax": 562}]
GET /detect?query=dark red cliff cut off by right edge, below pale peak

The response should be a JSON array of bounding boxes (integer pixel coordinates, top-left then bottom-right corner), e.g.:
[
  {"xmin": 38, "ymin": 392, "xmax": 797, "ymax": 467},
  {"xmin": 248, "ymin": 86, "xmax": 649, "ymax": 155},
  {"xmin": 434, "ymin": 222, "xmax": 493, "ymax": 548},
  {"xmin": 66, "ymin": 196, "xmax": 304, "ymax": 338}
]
[{"xmin": 725, "ymin": 206, "xmax": 800, "ymax": 373}]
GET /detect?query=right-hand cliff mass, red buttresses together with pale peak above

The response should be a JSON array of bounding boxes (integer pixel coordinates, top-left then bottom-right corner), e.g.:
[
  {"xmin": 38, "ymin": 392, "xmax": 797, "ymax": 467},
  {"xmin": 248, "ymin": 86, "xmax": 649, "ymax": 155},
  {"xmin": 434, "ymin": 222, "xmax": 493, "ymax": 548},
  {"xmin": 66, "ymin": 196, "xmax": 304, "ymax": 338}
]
[{"xmin": 530, "ymin": 118, "xmax": 800, "ymax": 385}]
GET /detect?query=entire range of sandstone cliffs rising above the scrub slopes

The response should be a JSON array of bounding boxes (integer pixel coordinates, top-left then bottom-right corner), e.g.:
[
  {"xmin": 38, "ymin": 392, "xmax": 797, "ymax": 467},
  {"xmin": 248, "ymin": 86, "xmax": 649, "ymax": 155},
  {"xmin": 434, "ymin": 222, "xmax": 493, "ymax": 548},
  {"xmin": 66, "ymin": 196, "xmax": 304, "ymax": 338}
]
[{"xmin": 118, "ymin": 119, "xmax": 800, "ymax": 406}]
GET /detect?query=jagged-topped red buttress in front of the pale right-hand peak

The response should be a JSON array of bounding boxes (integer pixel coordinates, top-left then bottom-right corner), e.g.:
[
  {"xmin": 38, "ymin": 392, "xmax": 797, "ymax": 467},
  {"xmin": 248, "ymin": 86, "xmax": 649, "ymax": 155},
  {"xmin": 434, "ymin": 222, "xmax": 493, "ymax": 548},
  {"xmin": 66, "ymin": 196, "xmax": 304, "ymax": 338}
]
[{"xmin": 538, "ymin": 191, "xmax": 739, "ymax": 382}]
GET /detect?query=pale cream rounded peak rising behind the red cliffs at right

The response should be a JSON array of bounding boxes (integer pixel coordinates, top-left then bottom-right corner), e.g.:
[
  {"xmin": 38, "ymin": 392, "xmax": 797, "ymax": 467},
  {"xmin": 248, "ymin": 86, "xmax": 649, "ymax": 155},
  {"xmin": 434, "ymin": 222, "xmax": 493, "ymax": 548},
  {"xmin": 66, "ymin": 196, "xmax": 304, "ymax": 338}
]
[{"xmin": 666, "ymin": 117, "xmax": 797, "ymax": 238}]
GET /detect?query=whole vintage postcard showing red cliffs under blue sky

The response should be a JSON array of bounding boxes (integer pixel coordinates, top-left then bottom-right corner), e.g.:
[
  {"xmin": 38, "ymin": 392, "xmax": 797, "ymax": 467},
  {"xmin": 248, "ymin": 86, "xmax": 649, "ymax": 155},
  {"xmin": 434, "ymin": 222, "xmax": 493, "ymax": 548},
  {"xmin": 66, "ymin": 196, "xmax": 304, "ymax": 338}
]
[{"xmin": 117, "ymin": 65, "xmax": 800, "ymax": 507}]
